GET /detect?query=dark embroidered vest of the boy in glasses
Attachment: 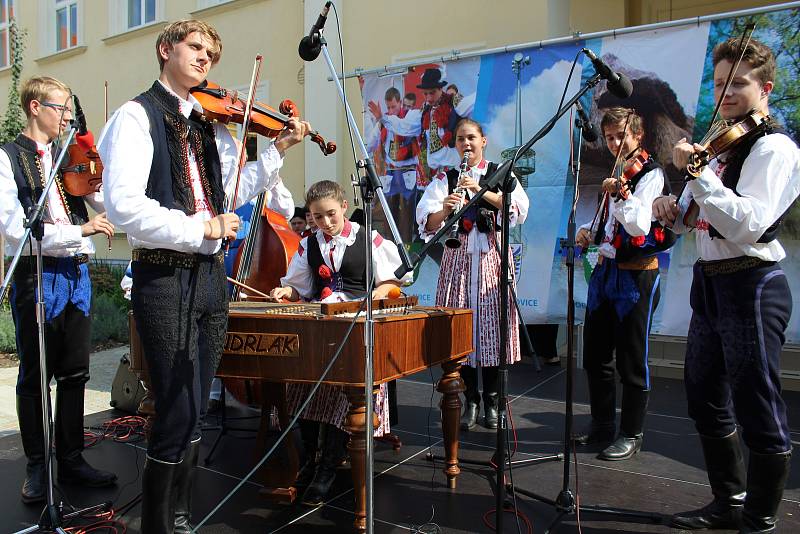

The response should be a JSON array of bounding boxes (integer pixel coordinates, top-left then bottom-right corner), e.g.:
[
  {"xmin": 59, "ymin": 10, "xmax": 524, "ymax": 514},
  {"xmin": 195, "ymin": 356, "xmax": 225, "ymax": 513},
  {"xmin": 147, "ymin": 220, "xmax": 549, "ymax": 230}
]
[{"xmin": 2, "ymin": 134, "xmax": 89, "ymax": 226}]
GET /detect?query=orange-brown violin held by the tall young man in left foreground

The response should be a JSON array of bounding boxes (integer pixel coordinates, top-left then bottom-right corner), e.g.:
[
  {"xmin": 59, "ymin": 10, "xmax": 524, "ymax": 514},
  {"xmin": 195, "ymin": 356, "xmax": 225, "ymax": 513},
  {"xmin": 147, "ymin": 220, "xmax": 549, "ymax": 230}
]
[{"xmin": 189, "ymin": 80, "xmax": 336, "ymax": 156}]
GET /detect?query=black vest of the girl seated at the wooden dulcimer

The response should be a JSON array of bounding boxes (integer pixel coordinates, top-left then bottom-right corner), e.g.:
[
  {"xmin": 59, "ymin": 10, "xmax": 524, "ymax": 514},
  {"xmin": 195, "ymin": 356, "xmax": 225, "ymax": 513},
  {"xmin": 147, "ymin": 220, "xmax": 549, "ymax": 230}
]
[{"xmin": 306, "ymin": 226, "xmax": 367, "ymax": 299}]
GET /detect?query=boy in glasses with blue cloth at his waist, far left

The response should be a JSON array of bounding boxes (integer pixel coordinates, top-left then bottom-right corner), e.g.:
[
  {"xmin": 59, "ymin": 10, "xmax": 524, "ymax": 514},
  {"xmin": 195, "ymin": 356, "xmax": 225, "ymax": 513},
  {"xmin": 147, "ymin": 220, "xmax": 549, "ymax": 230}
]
[{"xmin": 0, "ymin": 77, "xmax": 117, "ymax": 503}]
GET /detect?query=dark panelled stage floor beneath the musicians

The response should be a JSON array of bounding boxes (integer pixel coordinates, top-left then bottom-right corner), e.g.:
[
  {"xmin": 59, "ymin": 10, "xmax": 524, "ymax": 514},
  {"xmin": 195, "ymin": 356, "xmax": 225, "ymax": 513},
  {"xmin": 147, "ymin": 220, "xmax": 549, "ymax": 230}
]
[{"xmin": 0, "ymin": 361, "xmax": 800, "ymax": 534}]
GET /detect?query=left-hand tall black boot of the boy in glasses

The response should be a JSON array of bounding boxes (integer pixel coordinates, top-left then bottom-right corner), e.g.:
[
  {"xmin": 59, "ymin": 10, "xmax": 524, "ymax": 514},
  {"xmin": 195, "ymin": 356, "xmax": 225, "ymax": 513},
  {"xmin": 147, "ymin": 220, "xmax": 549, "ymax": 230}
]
[{"xmin": 17, "ymin": 396, "xmax": 47, "ymax": 504}]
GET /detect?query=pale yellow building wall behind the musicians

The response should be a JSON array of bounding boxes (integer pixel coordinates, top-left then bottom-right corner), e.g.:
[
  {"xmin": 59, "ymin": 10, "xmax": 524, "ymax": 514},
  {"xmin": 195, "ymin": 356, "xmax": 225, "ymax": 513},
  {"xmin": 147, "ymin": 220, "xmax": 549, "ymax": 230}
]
[{"xmin": 0, "ymin": 0, "xmax": 788, "ymax": 257}]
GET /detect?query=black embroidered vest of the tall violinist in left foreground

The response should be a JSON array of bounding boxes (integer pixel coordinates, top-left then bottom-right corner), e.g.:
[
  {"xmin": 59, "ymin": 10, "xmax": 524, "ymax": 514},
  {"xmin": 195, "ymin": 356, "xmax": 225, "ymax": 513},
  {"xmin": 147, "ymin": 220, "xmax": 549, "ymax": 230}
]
[{"xmin": 134, "ymin": 81, "xmax": 225, "ymax": 215}]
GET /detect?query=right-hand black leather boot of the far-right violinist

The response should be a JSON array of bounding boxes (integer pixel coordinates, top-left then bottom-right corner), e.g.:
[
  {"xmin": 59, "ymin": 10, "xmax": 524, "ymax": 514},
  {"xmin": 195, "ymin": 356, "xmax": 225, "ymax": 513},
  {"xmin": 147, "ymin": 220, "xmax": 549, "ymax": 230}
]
[{"xmin": 739, "ymin": 451, "xmax": 792, "ymax": 534}]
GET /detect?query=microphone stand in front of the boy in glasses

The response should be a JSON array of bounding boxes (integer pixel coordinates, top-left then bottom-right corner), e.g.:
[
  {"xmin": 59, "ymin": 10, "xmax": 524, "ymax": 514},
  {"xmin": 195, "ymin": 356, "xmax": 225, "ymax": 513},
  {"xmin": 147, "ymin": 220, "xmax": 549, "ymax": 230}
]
[{"xmin": 0, "ymin": 125, "xmax": 111, "ymax": 534}]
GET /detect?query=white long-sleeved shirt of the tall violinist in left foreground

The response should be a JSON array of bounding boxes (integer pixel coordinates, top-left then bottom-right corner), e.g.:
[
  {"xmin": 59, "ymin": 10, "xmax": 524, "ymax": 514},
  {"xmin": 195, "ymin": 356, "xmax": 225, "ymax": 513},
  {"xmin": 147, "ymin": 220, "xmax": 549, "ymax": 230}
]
[{"xmin": 97, "ymin": 82, "xmax": 283, "ymax": 254}]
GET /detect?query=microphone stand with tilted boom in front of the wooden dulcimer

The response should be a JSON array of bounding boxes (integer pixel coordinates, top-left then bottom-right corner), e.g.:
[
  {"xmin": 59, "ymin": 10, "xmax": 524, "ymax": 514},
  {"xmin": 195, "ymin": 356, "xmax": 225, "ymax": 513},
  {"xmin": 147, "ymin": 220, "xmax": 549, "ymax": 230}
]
[{"xmin": 304, "ymin": 32, "xmax": 414, "ymax": 534}]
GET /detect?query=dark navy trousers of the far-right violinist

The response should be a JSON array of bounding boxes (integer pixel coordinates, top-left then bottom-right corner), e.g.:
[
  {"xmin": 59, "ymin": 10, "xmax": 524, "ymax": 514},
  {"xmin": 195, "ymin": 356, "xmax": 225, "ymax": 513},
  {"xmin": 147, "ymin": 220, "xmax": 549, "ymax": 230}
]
[{"xmin": 684, "ymin": 263, "xmax": 792, "ymax": 454}]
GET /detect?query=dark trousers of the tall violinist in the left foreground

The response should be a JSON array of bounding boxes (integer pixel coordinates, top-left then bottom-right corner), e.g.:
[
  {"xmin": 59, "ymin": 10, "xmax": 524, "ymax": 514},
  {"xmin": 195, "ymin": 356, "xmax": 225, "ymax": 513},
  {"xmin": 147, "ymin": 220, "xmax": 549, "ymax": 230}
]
[{"xmin": 131, "ymin": 254, "xmax": 228, "ymax": 462}]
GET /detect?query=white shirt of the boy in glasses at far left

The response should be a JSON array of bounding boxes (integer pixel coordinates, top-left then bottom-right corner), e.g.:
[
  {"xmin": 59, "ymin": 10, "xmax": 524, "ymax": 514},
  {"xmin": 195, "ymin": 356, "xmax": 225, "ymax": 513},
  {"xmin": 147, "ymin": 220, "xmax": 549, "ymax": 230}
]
[{"xmin": 0, "ymin": 142, "xmax": 105, "ymax": 257}]
